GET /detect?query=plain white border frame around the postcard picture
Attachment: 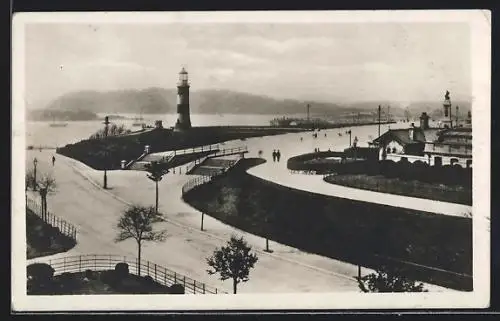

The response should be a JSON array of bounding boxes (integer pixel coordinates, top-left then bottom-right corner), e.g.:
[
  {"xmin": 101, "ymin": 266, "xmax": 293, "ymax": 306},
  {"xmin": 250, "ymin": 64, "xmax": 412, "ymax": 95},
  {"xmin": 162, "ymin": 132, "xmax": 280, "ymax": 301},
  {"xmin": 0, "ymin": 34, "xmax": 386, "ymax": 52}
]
[{"xmin": 11, "ymin": 10, "xmax": 491, "ymax": 311}]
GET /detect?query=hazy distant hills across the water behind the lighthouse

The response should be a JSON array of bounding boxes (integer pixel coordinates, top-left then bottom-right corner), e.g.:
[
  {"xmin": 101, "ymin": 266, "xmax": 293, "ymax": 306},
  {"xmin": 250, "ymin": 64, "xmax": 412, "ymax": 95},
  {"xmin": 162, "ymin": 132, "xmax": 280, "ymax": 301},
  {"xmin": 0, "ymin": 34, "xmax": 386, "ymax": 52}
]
[{"xmin": 40, "ymin": 87, "xmax": 470, "ymax": 117}]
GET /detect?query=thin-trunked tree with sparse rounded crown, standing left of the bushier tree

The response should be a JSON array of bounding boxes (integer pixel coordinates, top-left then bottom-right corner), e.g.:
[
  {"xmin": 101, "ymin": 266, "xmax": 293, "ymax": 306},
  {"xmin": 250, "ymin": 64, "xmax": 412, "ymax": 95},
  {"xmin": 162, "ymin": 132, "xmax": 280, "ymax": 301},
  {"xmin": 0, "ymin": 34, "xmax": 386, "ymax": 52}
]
[{"xmin": 115, "ymin": 205, "xmax": 166, "ymax": 275}]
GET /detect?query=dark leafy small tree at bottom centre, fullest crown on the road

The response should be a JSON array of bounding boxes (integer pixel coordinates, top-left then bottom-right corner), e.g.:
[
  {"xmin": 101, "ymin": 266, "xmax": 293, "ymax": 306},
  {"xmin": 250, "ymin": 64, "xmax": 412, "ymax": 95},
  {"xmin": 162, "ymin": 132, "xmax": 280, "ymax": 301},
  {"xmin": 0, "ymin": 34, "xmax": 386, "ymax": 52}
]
[{"xmin": 207, "ymin": 235, "xmax": 258, "ymax": 294}]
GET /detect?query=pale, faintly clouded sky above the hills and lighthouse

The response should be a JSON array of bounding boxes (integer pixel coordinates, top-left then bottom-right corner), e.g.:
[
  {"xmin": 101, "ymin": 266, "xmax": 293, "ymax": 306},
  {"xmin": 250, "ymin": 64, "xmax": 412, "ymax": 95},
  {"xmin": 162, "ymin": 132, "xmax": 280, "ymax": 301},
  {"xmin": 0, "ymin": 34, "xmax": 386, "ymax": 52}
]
[{"xmin": 25, "ymin": 23, "xmax": 471, "ymax": 105}]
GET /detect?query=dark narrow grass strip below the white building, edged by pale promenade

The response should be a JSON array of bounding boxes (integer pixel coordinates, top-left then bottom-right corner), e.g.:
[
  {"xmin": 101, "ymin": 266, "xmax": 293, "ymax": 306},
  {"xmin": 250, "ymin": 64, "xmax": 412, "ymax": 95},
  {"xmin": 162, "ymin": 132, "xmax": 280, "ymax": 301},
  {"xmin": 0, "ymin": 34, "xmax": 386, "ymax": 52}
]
[{"xmin": 325, "ymin": 174, "xmax": 472, "ymax": 205}]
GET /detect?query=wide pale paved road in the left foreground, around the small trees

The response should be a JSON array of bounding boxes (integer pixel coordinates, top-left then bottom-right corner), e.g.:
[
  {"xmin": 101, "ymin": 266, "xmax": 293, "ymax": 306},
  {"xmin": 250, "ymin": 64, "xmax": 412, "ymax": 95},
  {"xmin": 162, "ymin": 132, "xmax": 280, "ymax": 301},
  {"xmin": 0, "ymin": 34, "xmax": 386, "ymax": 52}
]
[{"xmin": 28, "ymin": 152, "xmax": 364, "ymax": 292}]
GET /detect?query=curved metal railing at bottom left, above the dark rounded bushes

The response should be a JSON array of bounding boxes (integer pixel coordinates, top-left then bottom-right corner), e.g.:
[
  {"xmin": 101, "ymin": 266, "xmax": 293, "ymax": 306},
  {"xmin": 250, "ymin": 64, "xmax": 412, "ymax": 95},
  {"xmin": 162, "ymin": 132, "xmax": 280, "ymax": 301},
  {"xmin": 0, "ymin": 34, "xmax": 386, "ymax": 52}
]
[{"xmin": 30, "ymin": 254, "xmax": 227, "ymax": 294}]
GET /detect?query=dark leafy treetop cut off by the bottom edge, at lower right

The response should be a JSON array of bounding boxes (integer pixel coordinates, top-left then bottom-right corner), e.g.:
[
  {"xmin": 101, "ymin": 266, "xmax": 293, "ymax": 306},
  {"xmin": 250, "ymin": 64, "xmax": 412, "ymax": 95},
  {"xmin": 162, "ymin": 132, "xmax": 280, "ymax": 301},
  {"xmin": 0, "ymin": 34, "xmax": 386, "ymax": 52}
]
[{"xmin": 358, "ymin": 267, "xmax": 427, "ymax": 292}]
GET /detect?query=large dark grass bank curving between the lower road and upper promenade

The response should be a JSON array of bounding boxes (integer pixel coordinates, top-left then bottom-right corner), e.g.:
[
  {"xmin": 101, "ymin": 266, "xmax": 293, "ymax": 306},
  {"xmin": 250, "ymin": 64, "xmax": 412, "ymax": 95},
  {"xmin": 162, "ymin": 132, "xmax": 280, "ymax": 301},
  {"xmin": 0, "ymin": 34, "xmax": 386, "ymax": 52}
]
[{"xmin": 184, "ymin": 159, "xmax": 472, "ymax": 290}]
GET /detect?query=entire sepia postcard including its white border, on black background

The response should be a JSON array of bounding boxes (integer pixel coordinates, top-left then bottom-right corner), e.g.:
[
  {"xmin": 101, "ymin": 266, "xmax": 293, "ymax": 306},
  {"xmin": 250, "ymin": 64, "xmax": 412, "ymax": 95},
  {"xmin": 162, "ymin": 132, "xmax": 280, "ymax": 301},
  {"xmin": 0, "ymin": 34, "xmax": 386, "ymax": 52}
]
[{"xmin": 12, "ymin": 10, "xmax": 491, "ymax": 311}]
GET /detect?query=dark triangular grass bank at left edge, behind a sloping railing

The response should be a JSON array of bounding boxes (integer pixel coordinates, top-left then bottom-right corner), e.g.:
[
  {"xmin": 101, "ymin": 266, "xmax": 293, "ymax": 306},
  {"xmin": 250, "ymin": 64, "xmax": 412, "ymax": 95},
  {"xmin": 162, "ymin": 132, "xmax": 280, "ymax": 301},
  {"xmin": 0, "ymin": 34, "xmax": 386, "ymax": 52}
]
[{"xmin": 26, "ymin": 209, "xmax": 76, "ymax": 259}]
